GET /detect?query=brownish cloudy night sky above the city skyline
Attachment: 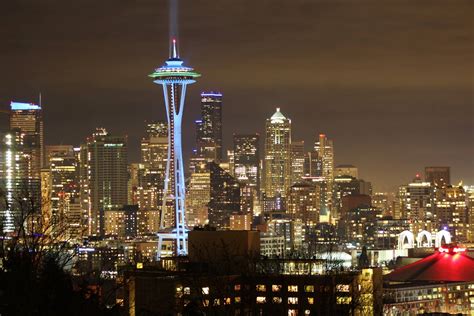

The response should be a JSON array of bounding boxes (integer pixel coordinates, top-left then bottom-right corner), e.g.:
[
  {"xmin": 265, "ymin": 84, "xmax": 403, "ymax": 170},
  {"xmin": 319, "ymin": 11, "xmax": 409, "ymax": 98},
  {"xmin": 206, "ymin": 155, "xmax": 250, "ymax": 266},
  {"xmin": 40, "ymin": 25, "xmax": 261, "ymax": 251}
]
[{"xmin": 0, "ymin": 0, "xmax": 474, "ymax": 190}]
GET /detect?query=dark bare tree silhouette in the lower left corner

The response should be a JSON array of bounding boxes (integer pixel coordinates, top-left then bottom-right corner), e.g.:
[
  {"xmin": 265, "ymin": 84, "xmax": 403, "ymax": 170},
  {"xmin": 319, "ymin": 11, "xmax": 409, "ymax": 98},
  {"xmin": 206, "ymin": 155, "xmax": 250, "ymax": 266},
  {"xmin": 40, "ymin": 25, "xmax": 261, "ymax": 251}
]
[{"xmin": 0, "ymin": 190, "xmax": 118, "ymax": 316}]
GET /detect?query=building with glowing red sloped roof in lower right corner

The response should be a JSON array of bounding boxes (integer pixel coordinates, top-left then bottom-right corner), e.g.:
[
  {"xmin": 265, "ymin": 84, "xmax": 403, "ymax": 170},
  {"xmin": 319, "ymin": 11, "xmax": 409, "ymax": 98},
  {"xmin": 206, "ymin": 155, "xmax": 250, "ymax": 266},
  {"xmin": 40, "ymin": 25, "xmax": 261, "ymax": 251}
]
[{"xmin": 384, "ymin": 245, "xmax": 474, "ymax": 315}]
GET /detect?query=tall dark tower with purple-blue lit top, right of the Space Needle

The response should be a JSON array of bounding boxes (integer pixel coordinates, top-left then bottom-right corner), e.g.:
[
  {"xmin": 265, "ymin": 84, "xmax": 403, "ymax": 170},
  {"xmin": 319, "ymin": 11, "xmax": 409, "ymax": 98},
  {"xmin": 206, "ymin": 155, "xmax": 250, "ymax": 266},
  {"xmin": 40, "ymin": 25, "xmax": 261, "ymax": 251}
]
[{"xmin": 195, "ymin": 92, "xmax": 222, "ymax": 163}]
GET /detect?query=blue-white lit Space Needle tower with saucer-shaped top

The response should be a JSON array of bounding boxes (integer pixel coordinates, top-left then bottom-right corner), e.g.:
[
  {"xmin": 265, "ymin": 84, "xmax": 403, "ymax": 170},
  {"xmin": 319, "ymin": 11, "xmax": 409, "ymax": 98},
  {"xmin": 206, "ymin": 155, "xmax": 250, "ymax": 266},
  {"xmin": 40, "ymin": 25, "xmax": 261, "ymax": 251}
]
[{"xmin": 150, "ymin": 38, "xmax": 200, "ymax": 258}]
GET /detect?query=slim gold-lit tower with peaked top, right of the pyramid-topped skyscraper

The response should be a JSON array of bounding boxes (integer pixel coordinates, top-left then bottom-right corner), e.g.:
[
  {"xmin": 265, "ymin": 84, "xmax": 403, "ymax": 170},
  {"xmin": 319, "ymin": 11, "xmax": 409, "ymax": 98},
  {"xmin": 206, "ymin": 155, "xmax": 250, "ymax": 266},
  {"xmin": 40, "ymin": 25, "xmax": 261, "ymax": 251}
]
[{"xmin": 314, "ymin": 134, "xmax": 338, "ymax": 221}]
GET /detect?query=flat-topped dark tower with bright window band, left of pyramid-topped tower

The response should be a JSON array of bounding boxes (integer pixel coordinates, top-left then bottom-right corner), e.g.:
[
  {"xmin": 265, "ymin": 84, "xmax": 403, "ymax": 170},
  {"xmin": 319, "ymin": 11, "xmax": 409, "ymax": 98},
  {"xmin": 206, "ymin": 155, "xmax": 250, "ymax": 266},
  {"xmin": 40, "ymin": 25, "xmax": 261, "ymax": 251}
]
[{"xmin": 233, "ymin": 134, "xmax": 260, "ymax": 192}]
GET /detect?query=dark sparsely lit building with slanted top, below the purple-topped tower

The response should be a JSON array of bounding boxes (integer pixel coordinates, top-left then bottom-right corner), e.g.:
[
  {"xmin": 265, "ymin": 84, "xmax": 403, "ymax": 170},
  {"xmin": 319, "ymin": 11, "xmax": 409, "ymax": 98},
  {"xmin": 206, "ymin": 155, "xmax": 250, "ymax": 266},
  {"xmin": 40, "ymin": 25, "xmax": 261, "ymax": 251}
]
[{"xmin": 208, "ymin": 162, "xmax": 241, "ymax": 229}]
